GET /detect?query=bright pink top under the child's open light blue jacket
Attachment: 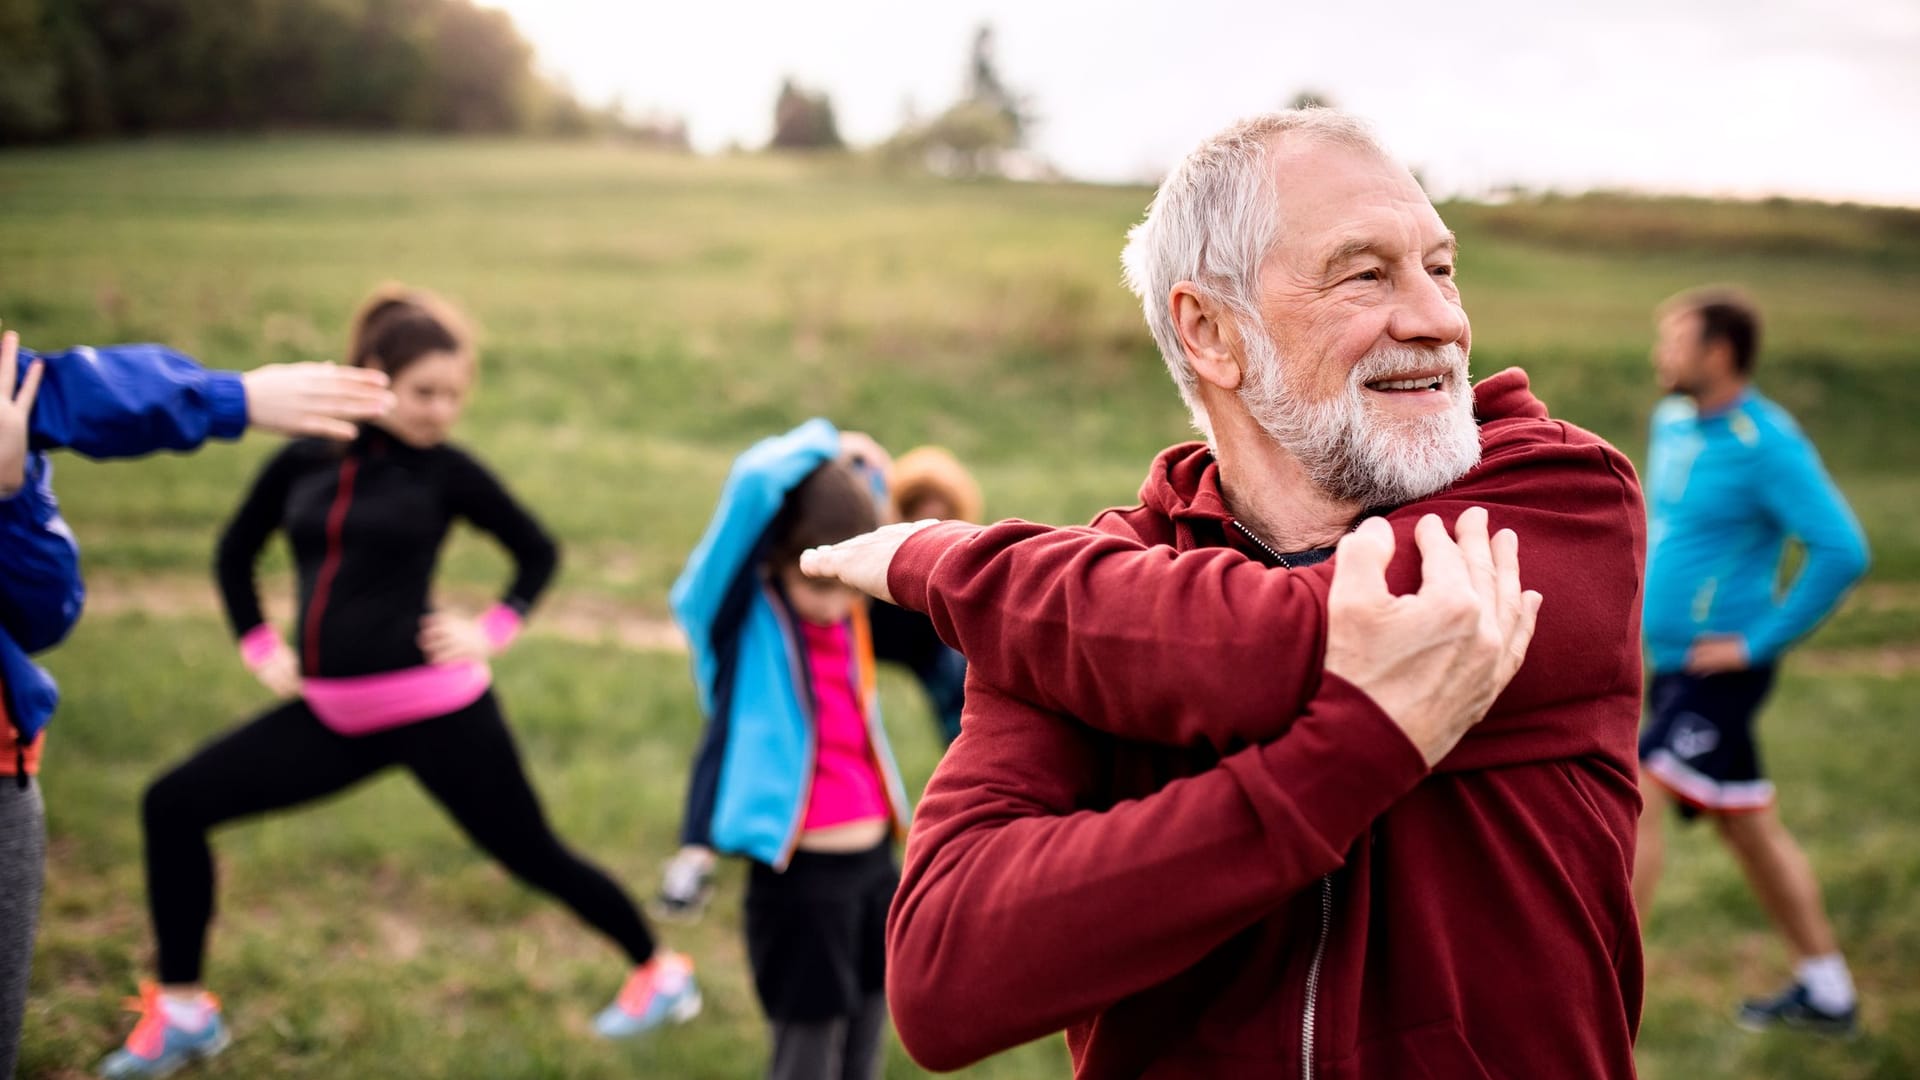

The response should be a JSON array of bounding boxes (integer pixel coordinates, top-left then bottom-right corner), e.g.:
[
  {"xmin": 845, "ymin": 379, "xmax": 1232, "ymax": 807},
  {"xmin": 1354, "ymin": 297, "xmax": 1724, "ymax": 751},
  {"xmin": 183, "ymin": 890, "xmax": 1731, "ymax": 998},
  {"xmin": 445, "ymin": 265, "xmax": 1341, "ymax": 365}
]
[{"xmin": 801, "ymin": 623, "xmax": 889, "ymax": 830}]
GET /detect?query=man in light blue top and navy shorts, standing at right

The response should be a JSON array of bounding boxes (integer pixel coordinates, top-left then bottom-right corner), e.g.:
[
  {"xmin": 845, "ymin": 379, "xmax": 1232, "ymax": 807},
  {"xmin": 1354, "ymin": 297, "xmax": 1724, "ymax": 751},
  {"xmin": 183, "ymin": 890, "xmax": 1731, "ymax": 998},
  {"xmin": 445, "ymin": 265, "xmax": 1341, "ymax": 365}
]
[{"xmin": 1634, "ymin": 290, "xmax": 1866, "ymax": 1034}]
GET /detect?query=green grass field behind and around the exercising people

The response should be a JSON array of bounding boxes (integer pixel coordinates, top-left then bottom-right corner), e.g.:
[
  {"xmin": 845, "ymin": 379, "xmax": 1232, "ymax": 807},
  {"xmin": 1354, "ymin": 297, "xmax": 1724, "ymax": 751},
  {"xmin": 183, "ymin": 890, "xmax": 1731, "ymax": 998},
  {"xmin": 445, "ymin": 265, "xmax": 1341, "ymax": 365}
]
[{"xmin": 0, "ymin": 138, "xmax": 1920, "ymax": 1080}]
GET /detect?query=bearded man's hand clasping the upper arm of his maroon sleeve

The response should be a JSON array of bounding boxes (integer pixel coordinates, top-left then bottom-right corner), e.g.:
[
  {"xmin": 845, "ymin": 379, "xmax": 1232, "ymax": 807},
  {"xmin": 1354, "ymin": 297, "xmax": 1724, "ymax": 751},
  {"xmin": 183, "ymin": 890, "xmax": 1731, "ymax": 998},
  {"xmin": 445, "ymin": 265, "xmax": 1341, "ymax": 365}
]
[{"xmin": 1327, "ymin": 507, "xmax": 1540, "ymax": 765}]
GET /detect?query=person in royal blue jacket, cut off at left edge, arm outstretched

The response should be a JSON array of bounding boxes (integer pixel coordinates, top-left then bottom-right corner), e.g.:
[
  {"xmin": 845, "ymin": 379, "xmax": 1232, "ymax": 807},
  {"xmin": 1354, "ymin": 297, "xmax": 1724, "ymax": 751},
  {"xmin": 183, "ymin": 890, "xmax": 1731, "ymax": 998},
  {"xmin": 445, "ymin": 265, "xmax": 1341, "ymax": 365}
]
[{"xmin": 0, "ymin": 322, "xmax": 392, "ymax": 1076}]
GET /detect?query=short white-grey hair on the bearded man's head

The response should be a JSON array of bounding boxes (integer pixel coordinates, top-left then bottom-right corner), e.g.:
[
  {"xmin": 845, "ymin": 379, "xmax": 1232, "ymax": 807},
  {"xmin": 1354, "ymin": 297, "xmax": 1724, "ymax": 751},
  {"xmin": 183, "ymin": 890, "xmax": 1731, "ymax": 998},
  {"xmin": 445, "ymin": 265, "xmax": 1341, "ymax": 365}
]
[{"xmin": 1119, "ymin": 108, "xmax": 1386, "ymax": 442}]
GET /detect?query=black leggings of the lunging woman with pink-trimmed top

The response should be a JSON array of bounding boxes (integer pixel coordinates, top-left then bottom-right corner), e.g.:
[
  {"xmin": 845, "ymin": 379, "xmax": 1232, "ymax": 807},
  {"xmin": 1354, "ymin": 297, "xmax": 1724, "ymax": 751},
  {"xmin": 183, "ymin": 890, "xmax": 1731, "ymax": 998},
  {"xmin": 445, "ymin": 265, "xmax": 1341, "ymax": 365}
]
[{"xmin": 142, "ymin": 692, "xmax": 653, "ymax": 984}]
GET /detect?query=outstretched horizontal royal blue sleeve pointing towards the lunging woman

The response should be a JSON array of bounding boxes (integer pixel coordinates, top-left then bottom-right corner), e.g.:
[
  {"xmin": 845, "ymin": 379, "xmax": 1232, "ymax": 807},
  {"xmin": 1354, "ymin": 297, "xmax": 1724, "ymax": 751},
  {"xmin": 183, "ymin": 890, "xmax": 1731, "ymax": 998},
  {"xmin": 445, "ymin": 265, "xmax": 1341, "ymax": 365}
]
[{"xmin": 19, "ymin": 346, "xmax": 246, "ymax": 457}]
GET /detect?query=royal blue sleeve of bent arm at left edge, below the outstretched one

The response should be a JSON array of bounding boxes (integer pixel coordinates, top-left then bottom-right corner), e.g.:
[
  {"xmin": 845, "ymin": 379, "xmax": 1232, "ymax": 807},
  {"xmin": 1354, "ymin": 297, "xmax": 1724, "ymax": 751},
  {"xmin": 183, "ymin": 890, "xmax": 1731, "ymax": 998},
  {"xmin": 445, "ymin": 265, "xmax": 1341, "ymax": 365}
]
[{"xmin": 0, "ymin": 454, "xmax": 86, "ymax": 653}]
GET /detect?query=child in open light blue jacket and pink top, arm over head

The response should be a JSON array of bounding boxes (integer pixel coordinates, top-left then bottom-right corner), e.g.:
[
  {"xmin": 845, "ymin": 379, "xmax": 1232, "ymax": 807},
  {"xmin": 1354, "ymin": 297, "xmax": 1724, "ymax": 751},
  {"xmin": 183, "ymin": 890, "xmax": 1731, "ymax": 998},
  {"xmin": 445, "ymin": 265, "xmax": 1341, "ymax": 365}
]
[{"xmin": 662, "ymin": 419, "xmax": 908, "ymax": 1080}]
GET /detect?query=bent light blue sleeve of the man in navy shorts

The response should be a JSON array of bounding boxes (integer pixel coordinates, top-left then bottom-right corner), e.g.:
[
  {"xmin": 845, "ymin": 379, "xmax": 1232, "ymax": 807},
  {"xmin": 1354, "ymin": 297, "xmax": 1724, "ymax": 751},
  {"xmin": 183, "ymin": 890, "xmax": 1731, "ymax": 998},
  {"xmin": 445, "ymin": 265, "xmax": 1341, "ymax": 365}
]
[{"xmin": 1745, "ymin": 430, "xmax": 1866, "ymax": 663}]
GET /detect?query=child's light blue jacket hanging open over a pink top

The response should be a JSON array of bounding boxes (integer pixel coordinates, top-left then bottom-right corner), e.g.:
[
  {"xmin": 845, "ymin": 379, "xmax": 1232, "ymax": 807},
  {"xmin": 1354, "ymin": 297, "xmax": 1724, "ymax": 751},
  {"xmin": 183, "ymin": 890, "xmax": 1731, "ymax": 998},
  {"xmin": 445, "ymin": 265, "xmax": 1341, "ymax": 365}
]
[{"xmin": 670, "ymin": 419, "xmax": 908, "ymax": 871}]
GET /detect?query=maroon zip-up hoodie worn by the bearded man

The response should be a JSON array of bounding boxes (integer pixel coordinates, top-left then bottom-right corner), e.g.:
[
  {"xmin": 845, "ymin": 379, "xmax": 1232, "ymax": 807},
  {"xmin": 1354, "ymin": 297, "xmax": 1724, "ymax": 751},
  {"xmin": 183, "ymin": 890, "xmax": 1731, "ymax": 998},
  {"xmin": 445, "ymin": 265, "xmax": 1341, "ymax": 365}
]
[{"xmin": 887, "ymin": 371, "xmax": 1645, "ymax": 1080}]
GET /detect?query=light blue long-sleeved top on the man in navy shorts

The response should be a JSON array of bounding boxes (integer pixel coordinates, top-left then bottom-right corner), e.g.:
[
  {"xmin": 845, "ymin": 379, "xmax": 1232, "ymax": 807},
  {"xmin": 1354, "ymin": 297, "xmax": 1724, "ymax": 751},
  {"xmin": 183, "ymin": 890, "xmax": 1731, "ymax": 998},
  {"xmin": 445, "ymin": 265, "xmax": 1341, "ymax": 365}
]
[{"xmin": 1642, "ymin": 390, "xmax": 1866, "ymax": 673}]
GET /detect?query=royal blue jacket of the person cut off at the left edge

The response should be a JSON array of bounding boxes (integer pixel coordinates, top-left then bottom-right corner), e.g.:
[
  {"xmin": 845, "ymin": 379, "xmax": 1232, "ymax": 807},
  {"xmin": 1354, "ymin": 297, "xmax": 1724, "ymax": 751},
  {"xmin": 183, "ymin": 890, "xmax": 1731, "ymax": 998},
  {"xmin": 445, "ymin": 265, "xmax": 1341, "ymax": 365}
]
[{"xmin": 0, "ymin": 346, "xmax": 246, "ymax": 744}]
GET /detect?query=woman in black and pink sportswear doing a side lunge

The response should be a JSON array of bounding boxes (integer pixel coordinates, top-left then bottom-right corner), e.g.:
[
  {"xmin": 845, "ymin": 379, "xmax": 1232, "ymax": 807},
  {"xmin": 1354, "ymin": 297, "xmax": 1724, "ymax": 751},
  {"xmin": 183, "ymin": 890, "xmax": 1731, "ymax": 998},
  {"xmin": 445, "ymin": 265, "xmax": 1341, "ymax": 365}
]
[{"xmin": 102, "ymin": 286, "xmax": 701, "ymax": 1078}]
